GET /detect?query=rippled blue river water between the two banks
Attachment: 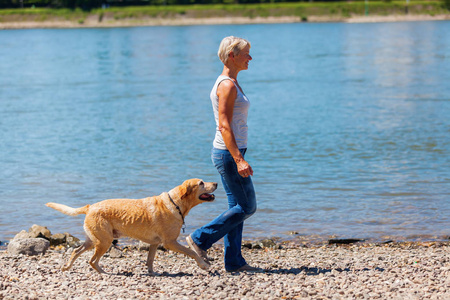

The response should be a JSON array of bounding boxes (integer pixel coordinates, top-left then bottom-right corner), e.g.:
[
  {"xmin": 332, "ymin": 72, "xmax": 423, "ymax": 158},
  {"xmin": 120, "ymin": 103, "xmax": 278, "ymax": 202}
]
[{"xmin": 0, "ymin": 21, "xmax": 450, "ymax": 241}]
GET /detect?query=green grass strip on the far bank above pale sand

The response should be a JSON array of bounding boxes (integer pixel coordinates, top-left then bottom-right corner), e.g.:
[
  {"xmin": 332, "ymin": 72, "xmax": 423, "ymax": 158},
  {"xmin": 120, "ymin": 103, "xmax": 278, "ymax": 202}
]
[{"xmin": 0, "ymin": 0, "xmax": 449, "ymax": 22}]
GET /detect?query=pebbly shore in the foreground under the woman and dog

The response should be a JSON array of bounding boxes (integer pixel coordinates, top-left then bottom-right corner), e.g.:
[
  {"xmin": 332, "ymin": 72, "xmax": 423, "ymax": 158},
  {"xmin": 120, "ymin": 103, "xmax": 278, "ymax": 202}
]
[{"xmin": 0, "ymin": 242, "xmax": 450, "ymax": 299}]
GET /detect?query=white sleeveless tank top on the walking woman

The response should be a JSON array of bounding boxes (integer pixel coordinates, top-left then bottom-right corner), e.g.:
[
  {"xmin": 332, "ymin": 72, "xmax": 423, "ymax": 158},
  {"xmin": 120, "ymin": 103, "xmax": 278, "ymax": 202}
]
[{"xmin": 210, "ymin": 75, "xmax": 250, "ymax": 150}]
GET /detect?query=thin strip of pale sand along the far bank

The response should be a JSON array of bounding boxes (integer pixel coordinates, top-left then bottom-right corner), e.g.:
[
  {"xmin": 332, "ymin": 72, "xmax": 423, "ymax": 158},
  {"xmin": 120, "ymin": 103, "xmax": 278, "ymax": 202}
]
[{"xmin": 0, "ymin": 14, "xmax": 450, "ymax": 29}]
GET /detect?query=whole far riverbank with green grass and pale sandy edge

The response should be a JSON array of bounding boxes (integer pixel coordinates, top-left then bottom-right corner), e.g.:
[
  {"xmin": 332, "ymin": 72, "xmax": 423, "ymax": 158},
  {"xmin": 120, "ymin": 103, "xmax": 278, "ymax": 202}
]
[{"xmin": 0, "ymin": 1, "xmax": 450, "ymax": 29}]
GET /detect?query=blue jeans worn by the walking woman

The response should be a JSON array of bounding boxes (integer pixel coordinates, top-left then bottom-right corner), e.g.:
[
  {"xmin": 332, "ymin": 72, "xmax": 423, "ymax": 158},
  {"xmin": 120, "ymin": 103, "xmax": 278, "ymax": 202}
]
[{"xmin": 191, "ymin": 148, "xmax": 256, "ymax": 271}]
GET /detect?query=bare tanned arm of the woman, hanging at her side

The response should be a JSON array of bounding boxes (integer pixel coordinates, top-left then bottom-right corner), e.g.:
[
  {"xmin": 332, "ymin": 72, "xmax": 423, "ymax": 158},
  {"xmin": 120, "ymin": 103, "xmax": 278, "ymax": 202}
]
[{"xmin": 217, "ymin": 80, "xmax": 253, "ymax": 177}]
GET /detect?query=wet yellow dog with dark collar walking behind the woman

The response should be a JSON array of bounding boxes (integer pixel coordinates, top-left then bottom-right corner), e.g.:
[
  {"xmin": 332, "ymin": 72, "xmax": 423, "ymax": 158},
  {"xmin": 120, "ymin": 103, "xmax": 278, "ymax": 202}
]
[{"xmin": 46, "ymin": 178, "xmax": 217, "ymax": 274}]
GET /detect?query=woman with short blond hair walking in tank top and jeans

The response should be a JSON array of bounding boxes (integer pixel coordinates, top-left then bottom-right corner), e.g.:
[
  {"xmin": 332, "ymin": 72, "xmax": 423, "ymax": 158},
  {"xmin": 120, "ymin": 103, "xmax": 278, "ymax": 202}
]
[{"xmin": 187, "ymin": 36, "xmax": 260, "ymax": 272}]
